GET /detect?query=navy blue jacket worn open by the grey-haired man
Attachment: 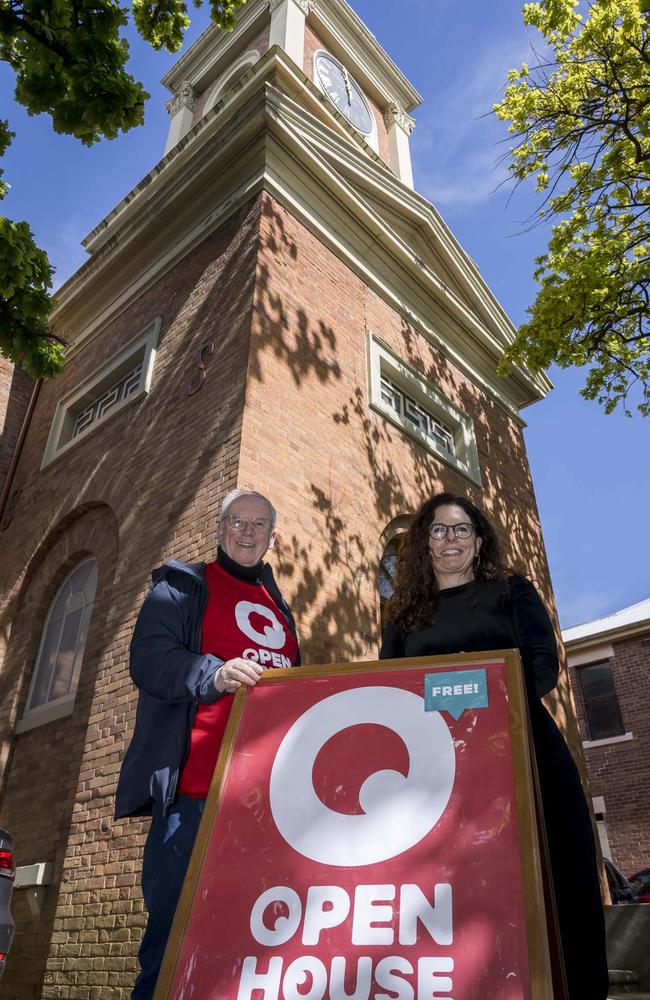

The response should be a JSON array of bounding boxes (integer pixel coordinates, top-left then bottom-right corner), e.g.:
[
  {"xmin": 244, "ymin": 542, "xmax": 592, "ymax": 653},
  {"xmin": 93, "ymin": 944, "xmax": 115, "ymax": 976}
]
[{"xmin": 115, "ymin": 561, "xmax": 300, "ymax": 819}]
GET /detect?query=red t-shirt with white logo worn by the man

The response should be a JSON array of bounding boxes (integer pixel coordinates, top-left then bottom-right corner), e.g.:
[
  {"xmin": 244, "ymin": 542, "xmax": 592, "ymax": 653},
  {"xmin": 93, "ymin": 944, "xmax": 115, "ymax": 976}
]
[{"xmin": 178, "ymin": 562, "xmax": 298, "ymax": 799}]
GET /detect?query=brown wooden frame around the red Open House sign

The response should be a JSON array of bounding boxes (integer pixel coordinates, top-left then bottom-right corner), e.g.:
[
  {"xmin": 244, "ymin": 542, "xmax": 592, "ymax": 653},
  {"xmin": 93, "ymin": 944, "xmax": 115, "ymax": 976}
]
[{"xmin": 154, "ymin": 650, "xmax": 562, "ymax": 1000}]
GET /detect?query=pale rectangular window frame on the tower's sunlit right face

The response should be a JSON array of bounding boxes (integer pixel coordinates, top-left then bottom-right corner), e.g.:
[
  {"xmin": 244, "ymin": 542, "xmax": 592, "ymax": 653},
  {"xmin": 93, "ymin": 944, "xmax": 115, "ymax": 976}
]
[{"xmin": 368, "ymin": 333, "xmax": 481, "ymax": 486}]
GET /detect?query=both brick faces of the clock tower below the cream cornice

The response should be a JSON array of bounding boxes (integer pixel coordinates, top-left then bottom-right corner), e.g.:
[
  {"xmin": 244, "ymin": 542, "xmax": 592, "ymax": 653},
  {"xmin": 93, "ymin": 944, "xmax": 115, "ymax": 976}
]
[{"xmin": 0, "ymin": 195, "xmax": 568, "ymax": 1000}]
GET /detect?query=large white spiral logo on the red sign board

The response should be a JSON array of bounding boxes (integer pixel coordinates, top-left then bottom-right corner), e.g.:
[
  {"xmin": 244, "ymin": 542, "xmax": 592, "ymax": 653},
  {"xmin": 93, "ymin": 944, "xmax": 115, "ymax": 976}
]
[{"xmin": 270, "ymin": 687, "xmax": 456, "ymax": 867}]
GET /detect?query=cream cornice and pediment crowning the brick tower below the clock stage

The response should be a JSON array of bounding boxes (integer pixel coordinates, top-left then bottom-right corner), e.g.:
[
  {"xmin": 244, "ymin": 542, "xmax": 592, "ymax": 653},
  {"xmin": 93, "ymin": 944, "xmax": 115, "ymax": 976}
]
[{"xmin": 52, "ymin": 49, "xmax": 550, "ymax": 413}]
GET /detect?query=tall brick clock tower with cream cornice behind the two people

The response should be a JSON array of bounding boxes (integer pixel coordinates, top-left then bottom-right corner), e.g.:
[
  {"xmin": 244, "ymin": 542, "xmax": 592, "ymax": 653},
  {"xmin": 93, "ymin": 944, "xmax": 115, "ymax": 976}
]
[{"xmin": 0, "ymin": 0, "xmax": 572, "ymax": 1000}]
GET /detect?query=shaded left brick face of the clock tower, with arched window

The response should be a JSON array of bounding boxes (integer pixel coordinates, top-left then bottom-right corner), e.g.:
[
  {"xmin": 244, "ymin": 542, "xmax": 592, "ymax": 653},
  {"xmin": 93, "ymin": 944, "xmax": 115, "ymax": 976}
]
[{"xmin": 0, "ymin": 202, "xmax": 259, "ymax": 1000}]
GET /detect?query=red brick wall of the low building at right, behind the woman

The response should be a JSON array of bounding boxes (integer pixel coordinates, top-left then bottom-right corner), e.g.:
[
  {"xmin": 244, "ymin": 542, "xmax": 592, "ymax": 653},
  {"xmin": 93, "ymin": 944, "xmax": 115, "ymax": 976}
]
[{"xmin": 571, "ymin": 626, "xmax": 650, "ymax": 875}]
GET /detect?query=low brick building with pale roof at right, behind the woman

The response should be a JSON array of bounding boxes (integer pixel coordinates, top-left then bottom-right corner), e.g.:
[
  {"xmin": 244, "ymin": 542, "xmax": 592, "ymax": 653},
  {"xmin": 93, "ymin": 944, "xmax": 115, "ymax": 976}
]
[{"xmin": 562, "ymin": 598, "xmax": 650, "ymax": 876}]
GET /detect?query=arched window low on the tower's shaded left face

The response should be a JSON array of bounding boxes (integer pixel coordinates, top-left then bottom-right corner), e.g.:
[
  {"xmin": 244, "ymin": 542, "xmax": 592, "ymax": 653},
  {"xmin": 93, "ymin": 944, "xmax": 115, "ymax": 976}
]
[{"xmin": 16, "ymin": 559, "xmax": 97, "ymax": 732}]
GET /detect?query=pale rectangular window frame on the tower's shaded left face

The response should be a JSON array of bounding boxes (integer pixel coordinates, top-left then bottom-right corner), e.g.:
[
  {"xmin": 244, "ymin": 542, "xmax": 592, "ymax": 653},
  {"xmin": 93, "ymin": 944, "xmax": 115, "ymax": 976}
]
[{"xmin": 41, "ymin": 316, "xmax": 160, "ymax": 469}]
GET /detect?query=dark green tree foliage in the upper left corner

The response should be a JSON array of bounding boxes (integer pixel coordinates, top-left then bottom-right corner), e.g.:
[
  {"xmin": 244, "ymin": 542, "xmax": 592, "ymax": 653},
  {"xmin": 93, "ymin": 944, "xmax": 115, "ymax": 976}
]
[{"xmin": 0, "ymin": 0, "xmax": 246, "ymax": 378}]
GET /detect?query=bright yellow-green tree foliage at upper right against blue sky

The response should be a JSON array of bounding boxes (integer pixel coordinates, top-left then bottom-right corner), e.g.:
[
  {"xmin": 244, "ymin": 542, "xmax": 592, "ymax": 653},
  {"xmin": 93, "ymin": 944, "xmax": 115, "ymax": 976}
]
[{"xmin": 495, "ymin": 0, "xmax": 650, "ymax": 416}]
